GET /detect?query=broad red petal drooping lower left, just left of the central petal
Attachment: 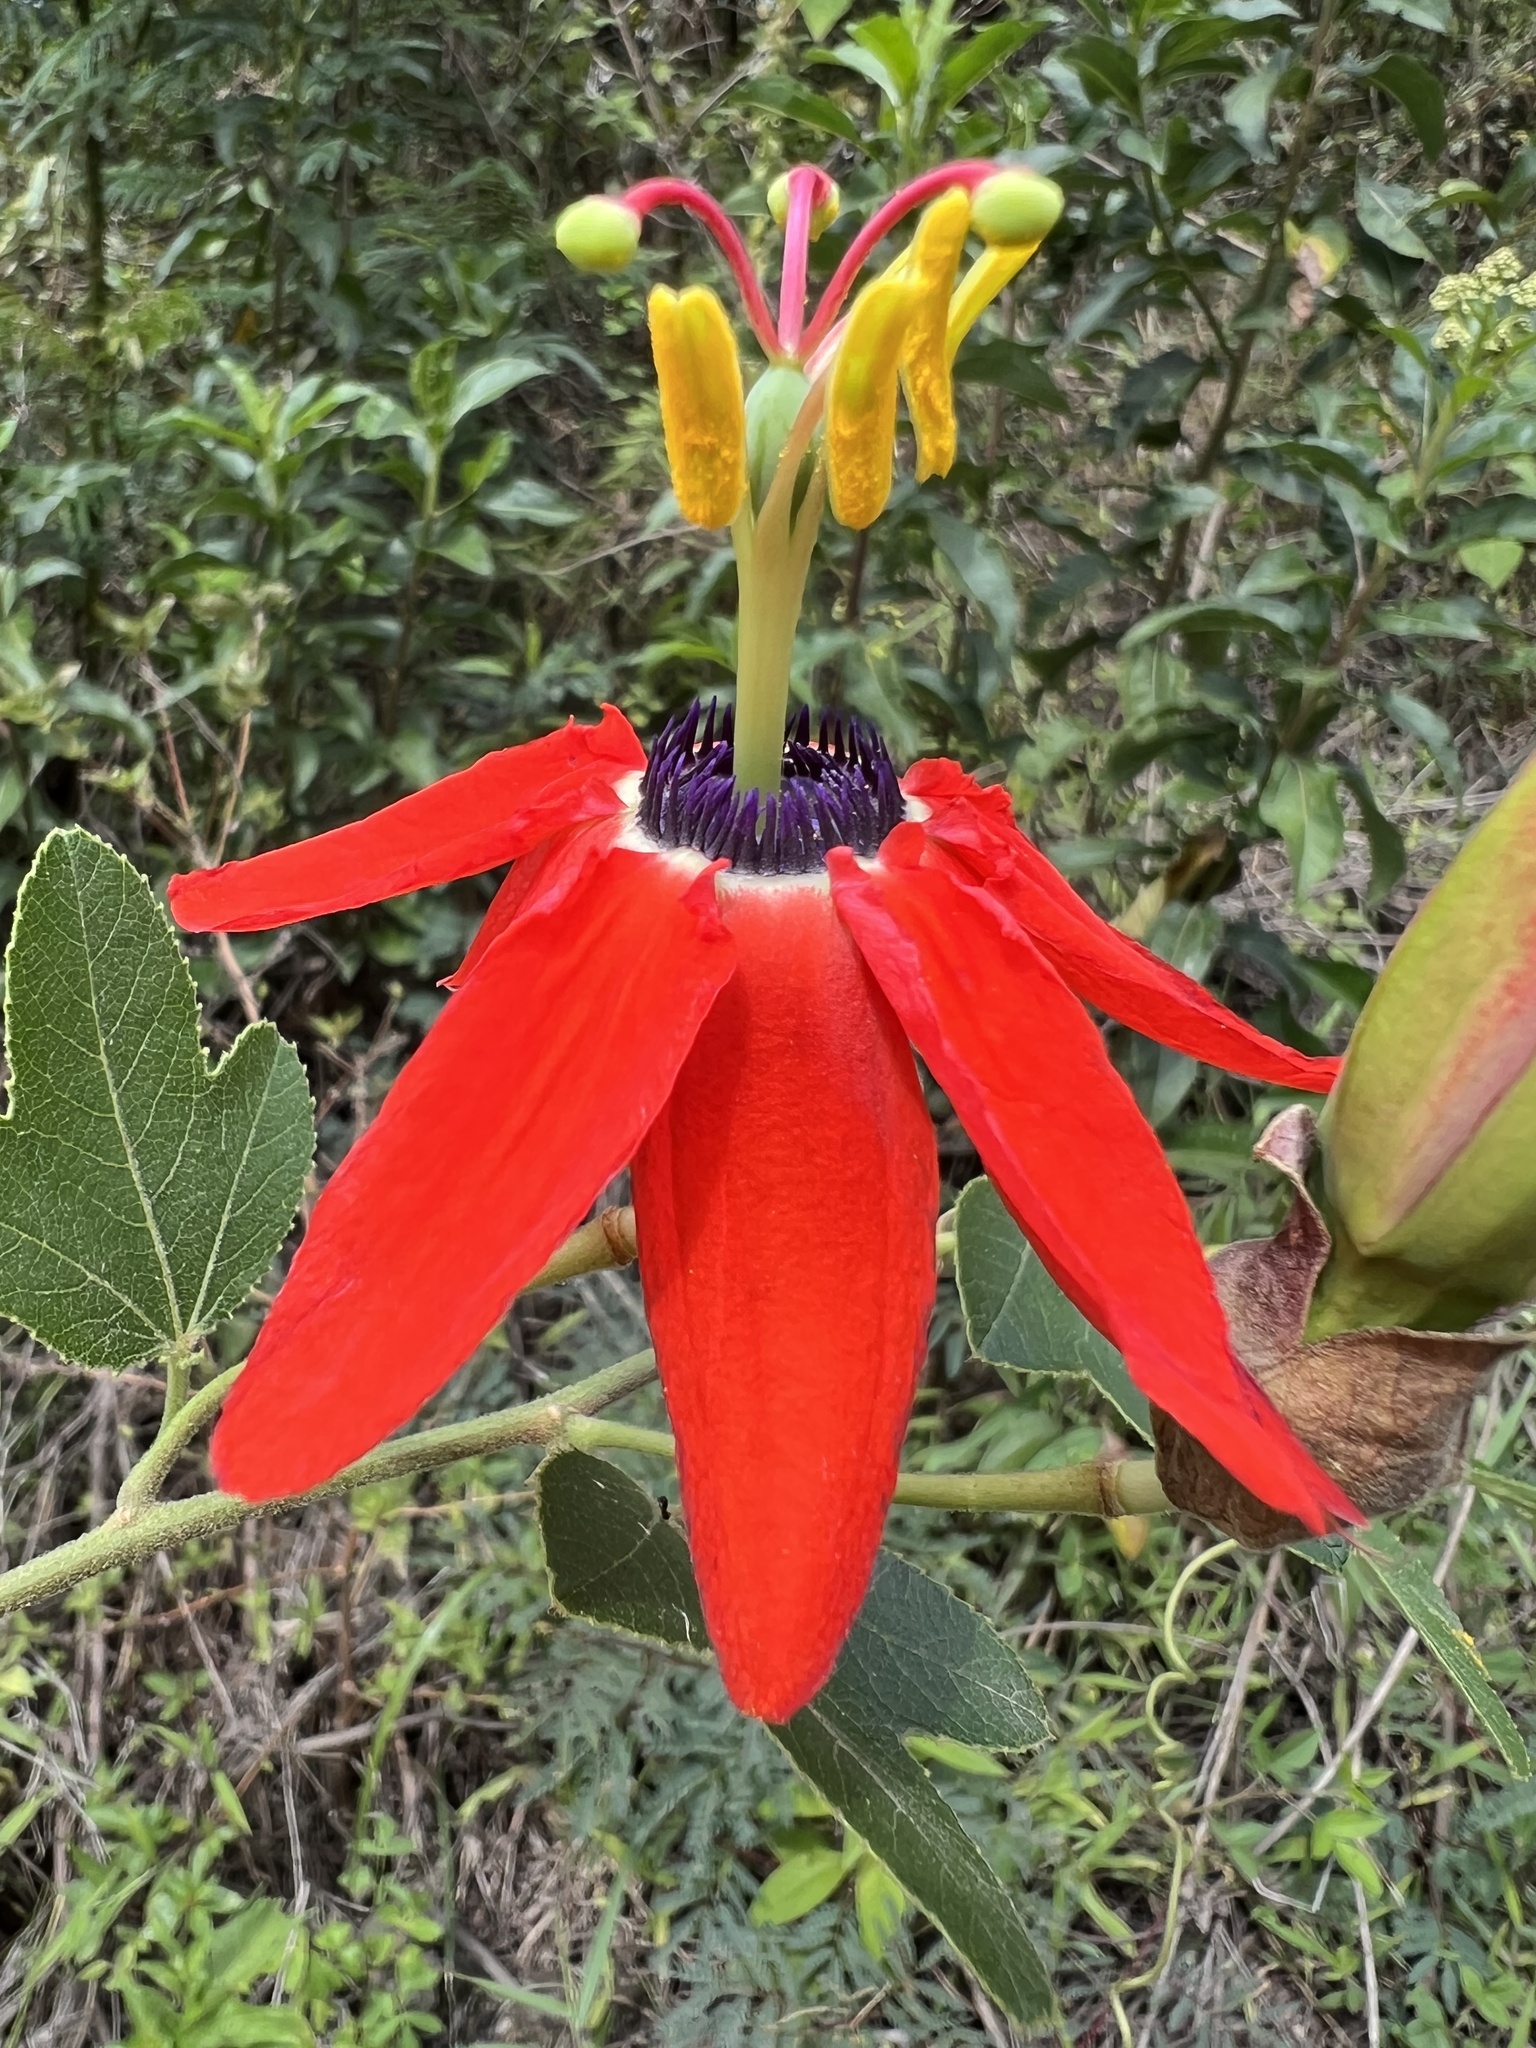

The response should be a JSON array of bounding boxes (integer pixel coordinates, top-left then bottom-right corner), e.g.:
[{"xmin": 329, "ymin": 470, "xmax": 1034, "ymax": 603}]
[{"xmin": 213, "ymin": 850, "xmax": 735, "ymax": 1499}]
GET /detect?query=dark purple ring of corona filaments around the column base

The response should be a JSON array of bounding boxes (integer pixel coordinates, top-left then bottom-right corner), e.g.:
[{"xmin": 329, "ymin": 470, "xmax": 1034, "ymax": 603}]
[{"xmin": 639, "ymin": 700, "xmax": 905, "ymax": 874}]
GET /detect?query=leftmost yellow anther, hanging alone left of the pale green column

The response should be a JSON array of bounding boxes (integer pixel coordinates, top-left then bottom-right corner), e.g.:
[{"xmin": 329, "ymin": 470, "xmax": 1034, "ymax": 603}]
[{"xmin": 647, "ymin": 285, "xmax": 748, "ymax": 526}]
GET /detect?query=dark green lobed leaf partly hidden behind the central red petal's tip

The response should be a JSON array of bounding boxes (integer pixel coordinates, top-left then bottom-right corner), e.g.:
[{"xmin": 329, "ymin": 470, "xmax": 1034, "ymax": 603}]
[{"xmin": 539, "ymin": 1450, "xmax": 1055, "ymax": 2025}]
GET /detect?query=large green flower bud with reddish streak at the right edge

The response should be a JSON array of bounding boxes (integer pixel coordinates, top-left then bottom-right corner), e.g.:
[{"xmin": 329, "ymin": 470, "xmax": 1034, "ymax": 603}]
[{"xmin": 1313, "ymin": 762, "xmax": 1536, "ymax": 1333}]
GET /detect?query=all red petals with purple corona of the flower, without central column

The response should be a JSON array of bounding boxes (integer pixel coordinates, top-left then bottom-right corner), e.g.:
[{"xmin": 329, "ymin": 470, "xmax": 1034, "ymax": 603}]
[{"xmin": 170, "ymin": 709, "xmax": 1358, "ymax": 1720}]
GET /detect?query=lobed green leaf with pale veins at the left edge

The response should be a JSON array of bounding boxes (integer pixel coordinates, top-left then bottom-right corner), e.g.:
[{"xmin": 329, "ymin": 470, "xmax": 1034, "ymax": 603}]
[{"xmin": 0, "ymin": 827, "xmax": 313, "ymax": 1368}]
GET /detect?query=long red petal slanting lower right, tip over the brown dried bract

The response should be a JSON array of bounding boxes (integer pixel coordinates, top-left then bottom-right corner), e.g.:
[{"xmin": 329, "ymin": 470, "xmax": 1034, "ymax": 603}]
[{"xmin": 827, "ymin": 825, "xmax": 1358, "ymax": 1530}]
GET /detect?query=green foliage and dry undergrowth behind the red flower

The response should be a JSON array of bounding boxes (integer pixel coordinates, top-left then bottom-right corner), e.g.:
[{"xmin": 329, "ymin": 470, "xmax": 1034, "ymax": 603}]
[{"xmin": 0, "ymin": 0, "xmax": 1536, "ymax": 2048}]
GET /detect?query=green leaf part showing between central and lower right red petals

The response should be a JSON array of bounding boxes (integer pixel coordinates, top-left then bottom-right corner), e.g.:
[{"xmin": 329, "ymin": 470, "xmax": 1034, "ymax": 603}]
[{"xmin": 954, "ymin": 1180, "xmax": 1151, "ymax": 1442}]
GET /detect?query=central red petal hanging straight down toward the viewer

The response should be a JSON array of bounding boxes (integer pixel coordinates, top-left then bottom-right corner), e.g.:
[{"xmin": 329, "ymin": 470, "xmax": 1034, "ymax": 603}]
[{"xmin": 635, "ymin": 879, "xmax": 938, "ymax": 1720}]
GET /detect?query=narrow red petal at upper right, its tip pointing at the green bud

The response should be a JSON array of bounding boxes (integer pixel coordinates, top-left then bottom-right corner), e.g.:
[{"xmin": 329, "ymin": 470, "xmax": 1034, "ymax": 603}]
[{"xmin": 901, "ymin": 762, "xmax": 1341, "ymax": 1096}]
